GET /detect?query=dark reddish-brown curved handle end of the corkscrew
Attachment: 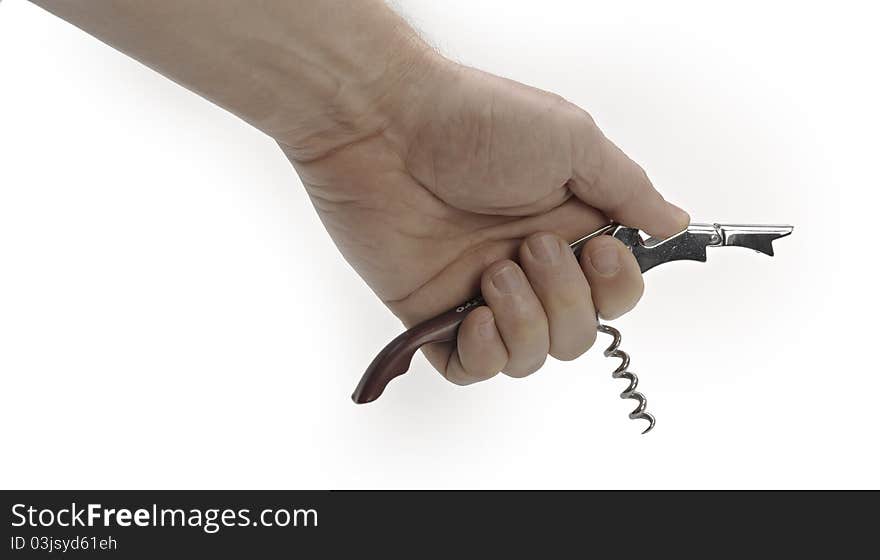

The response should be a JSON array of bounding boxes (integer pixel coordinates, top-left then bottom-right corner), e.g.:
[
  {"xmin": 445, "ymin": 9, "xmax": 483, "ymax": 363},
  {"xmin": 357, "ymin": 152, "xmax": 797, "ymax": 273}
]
[{"xmin": 351, "ymin": 297, "xmax": 484, "ymax": 404}]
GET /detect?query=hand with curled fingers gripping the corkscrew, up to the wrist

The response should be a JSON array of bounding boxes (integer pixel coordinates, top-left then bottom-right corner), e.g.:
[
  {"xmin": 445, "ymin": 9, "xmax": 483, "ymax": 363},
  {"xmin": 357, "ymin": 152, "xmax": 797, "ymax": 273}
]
[{"xmin": 282, "ymin": 53, "xmax": 689, "ymax": 384}]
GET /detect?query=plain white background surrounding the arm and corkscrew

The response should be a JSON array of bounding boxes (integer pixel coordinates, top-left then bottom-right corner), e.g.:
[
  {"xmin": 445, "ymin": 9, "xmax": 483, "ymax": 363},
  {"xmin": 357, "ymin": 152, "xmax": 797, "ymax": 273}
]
[{"xmin": 0, "ymin": 0, "xmax": 880, "ymax": 488}]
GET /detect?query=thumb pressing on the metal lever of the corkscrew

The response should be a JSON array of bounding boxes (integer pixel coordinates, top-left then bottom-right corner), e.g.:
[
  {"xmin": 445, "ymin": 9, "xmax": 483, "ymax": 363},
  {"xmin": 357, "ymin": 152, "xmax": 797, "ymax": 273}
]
[{"xmin": 568, "ymin": 105, "xmax": 690, "ymax": 238}]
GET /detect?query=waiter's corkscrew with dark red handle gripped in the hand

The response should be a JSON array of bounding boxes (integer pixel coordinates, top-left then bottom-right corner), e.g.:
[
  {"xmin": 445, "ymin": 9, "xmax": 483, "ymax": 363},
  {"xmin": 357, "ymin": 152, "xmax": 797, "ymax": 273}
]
[{"xmin": 352, "ymin": 223, "xmax": 794, "ymax": 433}]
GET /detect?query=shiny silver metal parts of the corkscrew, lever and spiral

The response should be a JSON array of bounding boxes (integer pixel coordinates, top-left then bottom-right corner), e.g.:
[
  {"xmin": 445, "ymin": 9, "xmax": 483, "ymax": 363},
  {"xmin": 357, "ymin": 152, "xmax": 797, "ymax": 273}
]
[{"xmin": 569, "ymin": 223, "xmax": 794, "ymax": 434}]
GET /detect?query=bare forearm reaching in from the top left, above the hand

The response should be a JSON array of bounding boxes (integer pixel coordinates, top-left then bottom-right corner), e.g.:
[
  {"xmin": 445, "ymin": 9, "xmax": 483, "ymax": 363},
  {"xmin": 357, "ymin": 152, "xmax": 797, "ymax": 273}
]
[{"xmin": 34, "ymin": 0, "xmax": 433, "ymax": 159}]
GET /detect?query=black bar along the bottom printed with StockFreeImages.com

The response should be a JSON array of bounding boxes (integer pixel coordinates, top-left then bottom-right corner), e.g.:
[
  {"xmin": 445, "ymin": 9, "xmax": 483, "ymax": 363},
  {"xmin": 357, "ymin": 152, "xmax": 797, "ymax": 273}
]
[{"xmin": 0, "ymin": 490, "xmax": 880, "ymax": 559}]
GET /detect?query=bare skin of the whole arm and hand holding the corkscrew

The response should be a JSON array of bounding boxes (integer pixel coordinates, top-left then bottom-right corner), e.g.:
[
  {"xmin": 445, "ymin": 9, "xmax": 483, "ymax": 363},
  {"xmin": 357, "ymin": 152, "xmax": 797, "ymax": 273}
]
[{"xmin": 36, "ymin": 0, "xmax": 689, "ymax": 385}]
